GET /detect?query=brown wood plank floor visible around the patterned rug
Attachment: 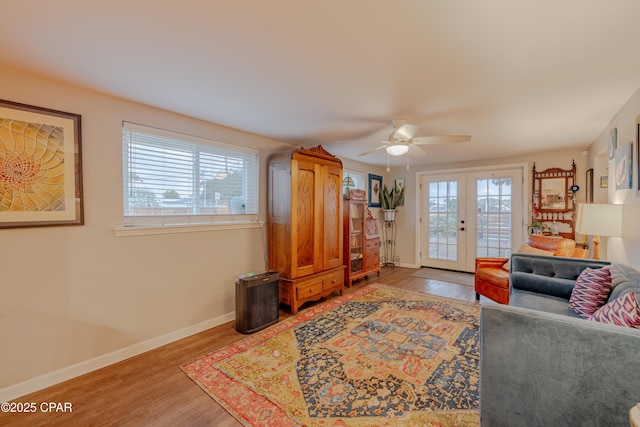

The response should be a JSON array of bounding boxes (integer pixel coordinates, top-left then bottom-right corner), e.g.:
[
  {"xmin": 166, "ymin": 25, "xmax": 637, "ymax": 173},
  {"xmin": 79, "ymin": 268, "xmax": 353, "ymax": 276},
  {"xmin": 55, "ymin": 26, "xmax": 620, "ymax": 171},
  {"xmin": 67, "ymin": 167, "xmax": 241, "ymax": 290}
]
[{"xmin": 0, "ymin": 267, "xmax": 482, "ymax": 427}]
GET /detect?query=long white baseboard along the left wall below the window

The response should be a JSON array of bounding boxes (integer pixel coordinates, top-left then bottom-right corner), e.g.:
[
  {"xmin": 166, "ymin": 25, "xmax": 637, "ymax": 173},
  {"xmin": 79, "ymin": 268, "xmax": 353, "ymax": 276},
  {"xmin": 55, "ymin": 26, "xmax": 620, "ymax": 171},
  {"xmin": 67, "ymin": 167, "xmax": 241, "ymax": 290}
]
[{"xmin": 0, "ymin": 311, "xmax": 236, "ymax": 402}]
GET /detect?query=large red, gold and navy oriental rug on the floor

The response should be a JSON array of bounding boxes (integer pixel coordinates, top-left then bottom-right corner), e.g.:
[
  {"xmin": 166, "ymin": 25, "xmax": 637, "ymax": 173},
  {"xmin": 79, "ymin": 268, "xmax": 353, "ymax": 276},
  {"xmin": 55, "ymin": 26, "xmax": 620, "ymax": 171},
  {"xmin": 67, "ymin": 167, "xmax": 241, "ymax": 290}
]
[{"xmin": 181, "ymin": 284, "xmax": 479, "ymax": 427}]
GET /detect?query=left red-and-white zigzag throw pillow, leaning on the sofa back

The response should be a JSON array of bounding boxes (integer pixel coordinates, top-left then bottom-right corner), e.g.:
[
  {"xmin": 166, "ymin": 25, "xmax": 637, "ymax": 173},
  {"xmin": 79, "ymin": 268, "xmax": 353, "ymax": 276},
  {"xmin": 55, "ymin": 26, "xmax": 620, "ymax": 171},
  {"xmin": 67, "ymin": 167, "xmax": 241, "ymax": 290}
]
[{"xmin": 569, "ymin": 266, "xmax": 611, "ymax": 317}]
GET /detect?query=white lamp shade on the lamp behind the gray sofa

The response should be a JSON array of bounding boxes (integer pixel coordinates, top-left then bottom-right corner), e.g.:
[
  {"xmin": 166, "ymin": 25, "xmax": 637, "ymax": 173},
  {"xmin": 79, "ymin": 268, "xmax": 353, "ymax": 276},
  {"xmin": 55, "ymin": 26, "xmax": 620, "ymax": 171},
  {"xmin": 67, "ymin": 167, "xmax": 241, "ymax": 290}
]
[{"xmin": 576, "ymin": 203, "xmax": 622, "ymax": 237}]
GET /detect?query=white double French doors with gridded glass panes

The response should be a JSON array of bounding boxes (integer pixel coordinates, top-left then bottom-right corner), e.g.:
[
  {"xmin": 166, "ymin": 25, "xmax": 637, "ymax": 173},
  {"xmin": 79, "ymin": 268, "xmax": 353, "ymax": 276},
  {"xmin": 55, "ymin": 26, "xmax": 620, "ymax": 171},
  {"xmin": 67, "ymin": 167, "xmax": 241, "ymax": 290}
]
[{"xmin": 420, "ymin": 168, "xmax": 524, "ymax": 272}]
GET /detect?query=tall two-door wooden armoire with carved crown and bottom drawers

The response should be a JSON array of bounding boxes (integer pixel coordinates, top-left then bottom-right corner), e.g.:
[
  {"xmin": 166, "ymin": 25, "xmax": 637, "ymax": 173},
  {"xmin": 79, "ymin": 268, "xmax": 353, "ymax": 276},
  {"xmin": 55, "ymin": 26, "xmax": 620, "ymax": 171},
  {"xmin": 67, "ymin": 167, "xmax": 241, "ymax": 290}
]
[{"xmin": 268, "ymin": 146, "xmax": 344, "ymax": 314}]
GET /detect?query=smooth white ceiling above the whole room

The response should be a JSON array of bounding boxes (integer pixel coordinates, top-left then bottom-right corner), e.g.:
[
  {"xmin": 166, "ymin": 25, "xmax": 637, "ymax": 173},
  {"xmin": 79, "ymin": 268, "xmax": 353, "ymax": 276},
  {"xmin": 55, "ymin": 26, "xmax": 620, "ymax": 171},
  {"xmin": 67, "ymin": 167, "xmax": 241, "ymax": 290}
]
[{"xmin": 0, "ymin": 0, "xmax": 640, "ymax": 165}]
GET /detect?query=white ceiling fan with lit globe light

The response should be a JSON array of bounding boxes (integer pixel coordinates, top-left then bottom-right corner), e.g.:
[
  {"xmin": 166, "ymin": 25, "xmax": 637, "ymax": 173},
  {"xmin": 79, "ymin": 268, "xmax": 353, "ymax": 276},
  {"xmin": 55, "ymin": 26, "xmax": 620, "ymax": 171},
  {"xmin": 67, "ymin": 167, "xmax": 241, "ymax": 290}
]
[{"xmin": 358, "ymin": 120, "xmax": 471, "ymax": 157}]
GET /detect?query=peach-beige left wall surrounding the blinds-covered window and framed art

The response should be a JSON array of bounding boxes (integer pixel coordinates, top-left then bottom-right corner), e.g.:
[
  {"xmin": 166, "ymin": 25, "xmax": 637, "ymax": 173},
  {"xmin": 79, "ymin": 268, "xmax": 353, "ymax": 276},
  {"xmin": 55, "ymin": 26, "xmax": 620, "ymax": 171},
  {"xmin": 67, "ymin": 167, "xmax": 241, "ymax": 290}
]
[{"xmin": 0, "ymin": 67, "xmax": 289, "ymax": 401}]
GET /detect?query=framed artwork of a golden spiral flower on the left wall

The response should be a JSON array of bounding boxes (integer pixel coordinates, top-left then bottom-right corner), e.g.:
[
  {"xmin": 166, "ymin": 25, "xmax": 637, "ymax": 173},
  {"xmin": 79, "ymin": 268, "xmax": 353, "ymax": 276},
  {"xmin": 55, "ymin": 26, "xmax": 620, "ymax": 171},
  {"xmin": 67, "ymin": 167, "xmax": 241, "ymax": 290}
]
[{"xmin": 0, "ymin": 100, "xmax": 84, "ymax": 228}]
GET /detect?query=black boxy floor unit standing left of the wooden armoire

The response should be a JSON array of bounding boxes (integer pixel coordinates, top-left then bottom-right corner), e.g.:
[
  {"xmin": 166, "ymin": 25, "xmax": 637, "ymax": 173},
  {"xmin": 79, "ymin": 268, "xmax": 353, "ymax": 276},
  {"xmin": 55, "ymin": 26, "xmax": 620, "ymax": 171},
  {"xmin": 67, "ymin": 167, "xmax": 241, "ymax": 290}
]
[{"xmin": 236, "ymin": 271, "xmax": 280, "ymax": 334}]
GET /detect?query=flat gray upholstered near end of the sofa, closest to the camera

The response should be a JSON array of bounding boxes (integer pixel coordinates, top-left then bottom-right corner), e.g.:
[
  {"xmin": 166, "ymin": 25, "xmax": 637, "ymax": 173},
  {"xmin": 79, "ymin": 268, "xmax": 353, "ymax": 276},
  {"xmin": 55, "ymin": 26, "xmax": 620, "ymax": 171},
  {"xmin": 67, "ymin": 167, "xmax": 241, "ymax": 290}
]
[{"xmin": 478, "ymin": 303, "xmax": 640, "ymax": 427}]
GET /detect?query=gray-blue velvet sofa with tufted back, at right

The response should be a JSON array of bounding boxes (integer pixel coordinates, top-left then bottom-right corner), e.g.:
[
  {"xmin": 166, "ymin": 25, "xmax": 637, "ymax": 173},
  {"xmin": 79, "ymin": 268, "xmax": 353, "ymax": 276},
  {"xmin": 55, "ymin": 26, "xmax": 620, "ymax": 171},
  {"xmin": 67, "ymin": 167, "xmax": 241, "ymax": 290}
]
[{"xmin": 480, "ymin": 254, "xmax": 640, "ymax": 427}]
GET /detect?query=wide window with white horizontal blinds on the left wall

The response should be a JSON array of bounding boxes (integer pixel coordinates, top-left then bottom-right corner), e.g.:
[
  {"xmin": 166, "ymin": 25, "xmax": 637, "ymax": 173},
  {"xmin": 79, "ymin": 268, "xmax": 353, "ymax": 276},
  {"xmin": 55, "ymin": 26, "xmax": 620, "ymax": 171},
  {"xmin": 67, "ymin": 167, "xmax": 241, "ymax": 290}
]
[{"xmin": 122, "ymin": 122, "xmax": 259, "ymax": 225}]
